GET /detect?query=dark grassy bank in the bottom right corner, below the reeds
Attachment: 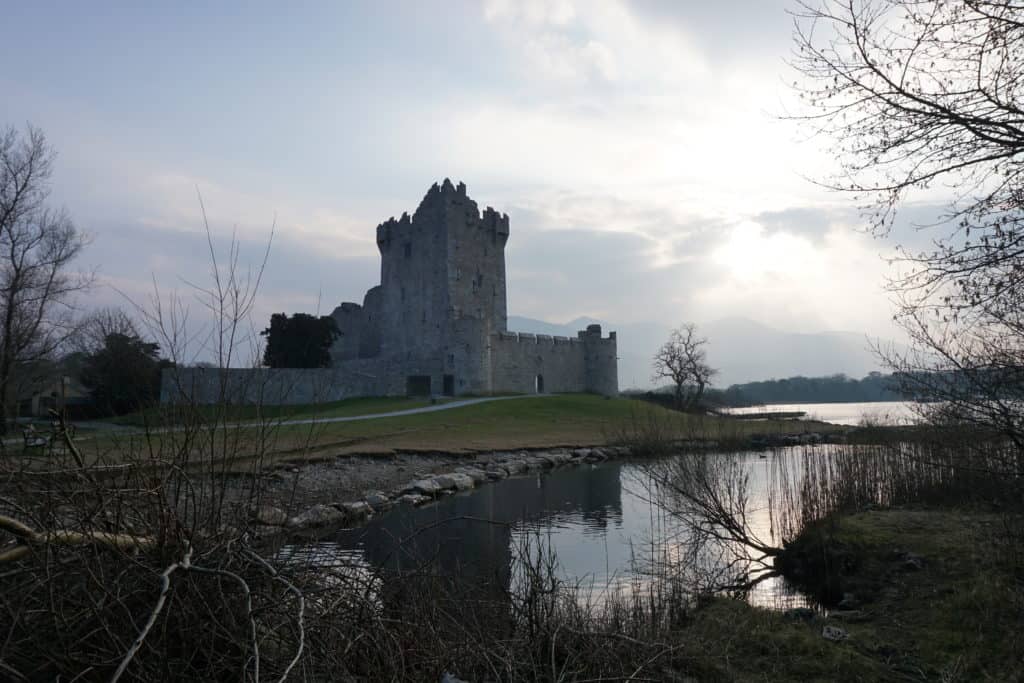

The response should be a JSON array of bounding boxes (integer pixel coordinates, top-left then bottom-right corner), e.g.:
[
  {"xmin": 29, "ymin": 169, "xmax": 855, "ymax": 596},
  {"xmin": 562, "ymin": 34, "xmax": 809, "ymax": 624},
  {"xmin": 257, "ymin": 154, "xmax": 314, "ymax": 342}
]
[{"xmin": 745, "ymin": 509, "xmax": 1024, "ymax": 682}]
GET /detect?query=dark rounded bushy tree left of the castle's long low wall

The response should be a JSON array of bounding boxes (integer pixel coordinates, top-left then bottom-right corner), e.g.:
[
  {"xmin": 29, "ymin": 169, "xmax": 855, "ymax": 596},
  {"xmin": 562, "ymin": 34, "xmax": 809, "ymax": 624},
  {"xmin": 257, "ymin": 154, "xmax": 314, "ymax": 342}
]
[{"xmin": 81, "ymin": 332, "xmax": 170, "ymax": 415}]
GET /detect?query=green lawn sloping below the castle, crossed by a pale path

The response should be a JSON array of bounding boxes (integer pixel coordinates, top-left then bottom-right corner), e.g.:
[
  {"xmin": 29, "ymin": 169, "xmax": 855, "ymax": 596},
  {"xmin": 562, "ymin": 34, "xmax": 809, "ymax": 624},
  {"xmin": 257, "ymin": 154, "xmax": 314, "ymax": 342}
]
[{"xmin": 61, "ymin": 394, "xmax": 831, "ymax": 468}]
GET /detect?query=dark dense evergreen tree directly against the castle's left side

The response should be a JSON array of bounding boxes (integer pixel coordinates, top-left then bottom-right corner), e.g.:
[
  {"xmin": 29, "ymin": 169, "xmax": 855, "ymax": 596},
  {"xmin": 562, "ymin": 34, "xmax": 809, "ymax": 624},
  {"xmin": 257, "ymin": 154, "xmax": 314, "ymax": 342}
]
[{"xmin": 260, "ymin": 313, "xmax": 341, "ymax": 368}]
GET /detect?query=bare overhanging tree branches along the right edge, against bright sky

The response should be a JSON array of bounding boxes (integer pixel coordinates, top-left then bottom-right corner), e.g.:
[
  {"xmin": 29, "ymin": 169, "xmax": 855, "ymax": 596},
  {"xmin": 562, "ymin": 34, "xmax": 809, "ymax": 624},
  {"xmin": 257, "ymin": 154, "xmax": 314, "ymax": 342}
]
[{"xmin": 794, "ymin": 0, "xmax": 1024, "ymax": 458}]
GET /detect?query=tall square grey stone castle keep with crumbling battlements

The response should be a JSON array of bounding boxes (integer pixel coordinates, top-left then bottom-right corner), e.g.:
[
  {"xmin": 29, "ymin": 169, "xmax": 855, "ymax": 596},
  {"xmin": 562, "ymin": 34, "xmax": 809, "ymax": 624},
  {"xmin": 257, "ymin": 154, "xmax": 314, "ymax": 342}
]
[{"xmin": 368, "ymin": 178, "xmax": 509, "ymax": 393}]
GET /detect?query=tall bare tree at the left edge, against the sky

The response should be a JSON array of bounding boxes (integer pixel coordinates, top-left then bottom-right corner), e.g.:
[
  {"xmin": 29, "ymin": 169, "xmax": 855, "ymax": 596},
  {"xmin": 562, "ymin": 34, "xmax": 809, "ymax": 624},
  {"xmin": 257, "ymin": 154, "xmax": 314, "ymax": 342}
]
[{"xmin": 0, "ymin": 126, "xmax": 90, "ymax": 433}]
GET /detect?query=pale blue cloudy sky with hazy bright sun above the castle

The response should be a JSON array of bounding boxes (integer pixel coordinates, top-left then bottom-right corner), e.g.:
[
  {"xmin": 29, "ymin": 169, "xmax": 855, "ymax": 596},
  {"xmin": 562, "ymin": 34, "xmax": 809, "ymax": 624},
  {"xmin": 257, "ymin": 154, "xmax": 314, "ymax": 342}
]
[{"xmin": 0, "ymin": 0, "xmax": 929, "ymax": 362}]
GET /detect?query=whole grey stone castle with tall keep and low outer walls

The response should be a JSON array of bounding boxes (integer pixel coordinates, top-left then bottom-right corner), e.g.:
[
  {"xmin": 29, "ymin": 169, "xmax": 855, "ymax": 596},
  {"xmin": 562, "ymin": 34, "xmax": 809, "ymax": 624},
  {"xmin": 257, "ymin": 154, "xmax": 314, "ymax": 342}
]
[{"xmin": 164, "ymin": 179, "xmax": 618, "ymax": 403}]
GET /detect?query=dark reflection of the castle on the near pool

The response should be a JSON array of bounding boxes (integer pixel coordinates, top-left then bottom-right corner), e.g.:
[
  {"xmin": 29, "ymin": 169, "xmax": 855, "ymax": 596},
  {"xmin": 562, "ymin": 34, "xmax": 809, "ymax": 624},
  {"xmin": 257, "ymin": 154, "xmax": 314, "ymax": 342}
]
[{"xmin": 335, "ymin": 464, "xmax": 623, "ymax": 588}]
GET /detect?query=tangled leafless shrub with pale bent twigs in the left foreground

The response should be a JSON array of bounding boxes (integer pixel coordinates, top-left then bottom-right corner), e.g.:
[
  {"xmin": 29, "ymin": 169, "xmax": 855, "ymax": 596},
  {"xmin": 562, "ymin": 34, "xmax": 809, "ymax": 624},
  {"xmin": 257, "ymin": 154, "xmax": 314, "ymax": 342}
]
[{"xmin": 0, "ymin": 205, "xmax": 339, "ymax": 681}]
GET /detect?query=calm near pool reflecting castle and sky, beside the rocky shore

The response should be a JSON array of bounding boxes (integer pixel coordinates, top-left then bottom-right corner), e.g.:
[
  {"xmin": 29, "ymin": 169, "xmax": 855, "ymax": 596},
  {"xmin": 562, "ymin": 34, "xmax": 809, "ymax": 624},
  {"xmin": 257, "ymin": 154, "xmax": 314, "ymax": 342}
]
[{"xmin": 287, "ymin": 450, "xmax": 806, "ymax": 607}]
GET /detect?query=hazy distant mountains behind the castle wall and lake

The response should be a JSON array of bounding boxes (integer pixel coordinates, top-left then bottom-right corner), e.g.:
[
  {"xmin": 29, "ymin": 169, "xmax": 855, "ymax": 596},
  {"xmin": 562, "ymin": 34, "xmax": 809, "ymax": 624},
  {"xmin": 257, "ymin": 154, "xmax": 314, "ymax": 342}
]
[{"xmin": 508, "ymin": 315, "xmax": 897, "ymax": 389}]
